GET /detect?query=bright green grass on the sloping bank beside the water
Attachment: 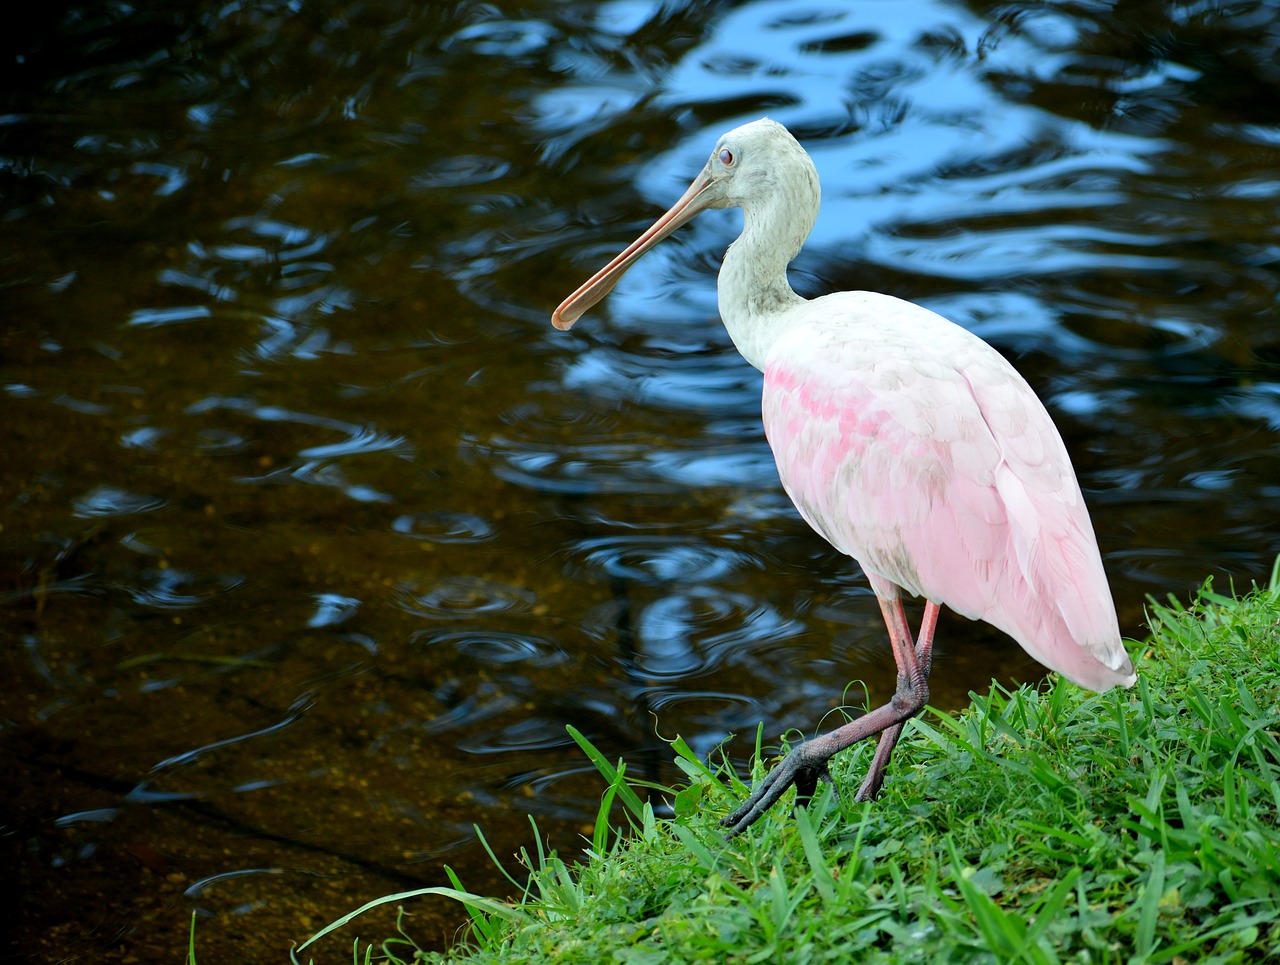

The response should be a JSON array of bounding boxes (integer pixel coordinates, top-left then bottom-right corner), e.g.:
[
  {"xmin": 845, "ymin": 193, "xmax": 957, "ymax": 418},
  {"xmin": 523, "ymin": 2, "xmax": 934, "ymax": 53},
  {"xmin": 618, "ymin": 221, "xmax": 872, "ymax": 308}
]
[{"xmin": 294, "ymin": 561, "xmax": 1280, "ymax": 965}]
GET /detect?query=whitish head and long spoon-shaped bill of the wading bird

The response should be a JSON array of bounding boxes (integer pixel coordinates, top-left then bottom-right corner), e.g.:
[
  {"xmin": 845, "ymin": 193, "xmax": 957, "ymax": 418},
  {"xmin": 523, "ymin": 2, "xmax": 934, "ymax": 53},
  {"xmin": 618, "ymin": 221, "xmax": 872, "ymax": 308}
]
[{"xmin": 552, "ymin": 118, "xmax": 819, "ymax": 330}]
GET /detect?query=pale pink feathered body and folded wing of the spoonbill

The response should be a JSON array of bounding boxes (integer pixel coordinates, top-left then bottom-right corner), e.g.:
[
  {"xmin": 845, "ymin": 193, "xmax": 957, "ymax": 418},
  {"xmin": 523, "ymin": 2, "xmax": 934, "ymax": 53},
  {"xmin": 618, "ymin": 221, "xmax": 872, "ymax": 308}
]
[{"xmin": 763, "ymin": 292, "xmax": 1133, "ymax": 690}]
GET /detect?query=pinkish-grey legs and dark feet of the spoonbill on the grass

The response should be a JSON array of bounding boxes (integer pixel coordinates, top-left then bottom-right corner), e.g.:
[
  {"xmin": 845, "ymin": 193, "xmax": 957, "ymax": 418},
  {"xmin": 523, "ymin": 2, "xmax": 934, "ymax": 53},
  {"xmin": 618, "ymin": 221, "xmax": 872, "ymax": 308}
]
[{"xmin": 721, "ymin": 577, "xmax": 937, "ymax": 837}]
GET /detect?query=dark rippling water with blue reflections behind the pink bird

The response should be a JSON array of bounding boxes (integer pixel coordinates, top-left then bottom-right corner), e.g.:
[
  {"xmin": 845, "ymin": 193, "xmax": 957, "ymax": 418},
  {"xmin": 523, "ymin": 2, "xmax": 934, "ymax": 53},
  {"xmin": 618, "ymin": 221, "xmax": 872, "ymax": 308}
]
[{"xmin": 0, "ymin": 0, "xmax": 1280, "ymax": 961}]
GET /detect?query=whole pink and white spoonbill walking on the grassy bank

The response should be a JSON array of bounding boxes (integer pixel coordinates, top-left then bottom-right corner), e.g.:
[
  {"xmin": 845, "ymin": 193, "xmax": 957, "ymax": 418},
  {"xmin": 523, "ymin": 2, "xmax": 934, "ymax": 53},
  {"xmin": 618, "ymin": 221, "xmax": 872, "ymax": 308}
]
[{"xmin": 552, "ymin": 118, "xmax": 1137, "ymax": 838}]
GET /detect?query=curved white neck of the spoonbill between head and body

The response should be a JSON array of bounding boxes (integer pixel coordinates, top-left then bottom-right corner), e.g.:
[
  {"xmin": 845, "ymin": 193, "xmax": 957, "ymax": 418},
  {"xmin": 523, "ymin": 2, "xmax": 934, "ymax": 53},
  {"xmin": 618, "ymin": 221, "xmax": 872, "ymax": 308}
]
[{"xmin": 717, "ymin": 198, "xmax": 813, "ymax": 370}]
